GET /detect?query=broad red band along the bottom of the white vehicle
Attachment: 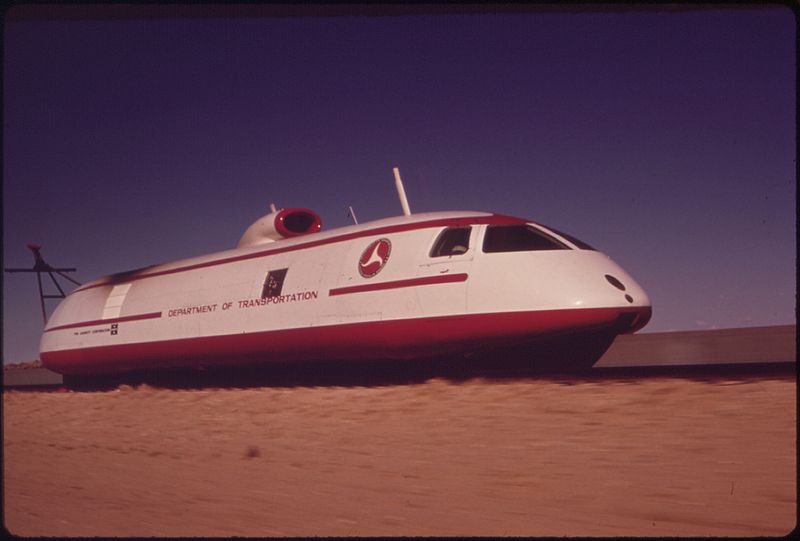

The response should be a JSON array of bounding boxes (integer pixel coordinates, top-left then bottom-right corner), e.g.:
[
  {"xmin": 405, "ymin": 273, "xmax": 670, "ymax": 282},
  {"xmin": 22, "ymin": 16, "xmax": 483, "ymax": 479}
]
[{"xmin": 41, "ymin": 307, "xmax": 650, "ymax": 374}]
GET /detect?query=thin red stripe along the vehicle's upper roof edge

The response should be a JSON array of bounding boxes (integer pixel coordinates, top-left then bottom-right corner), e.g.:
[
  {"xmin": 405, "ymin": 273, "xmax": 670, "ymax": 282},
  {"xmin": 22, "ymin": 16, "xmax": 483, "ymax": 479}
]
[{"xmin": 75, "ymin": 214, "xmax": 533, "ymax": 291}]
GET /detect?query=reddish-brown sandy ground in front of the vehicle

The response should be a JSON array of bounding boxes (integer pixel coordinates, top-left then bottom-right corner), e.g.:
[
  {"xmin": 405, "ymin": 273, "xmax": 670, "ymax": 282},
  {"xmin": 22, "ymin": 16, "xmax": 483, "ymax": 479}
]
[{"xmin": 3, "ymin": 377, "xmax": 797, "ymax": 536}]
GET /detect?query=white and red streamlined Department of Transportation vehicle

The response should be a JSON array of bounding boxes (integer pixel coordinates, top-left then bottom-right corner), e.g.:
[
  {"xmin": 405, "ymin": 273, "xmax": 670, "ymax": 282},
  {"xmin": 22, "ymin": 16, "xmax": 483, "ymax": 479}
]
[{"xmin": 36, "ymin": 174, "xmax": 651, "ymax": 375}]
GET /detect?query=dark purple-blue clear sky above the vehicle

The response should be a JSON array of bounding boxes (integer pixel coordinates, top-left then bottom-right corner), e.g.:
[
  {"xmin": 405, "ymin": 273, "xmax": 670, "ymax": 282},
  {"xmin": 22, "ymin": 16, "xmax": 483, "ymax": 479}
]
[{"xmin": 3, "ymin": 6, "xmax": 796, "ymax": 362}]
